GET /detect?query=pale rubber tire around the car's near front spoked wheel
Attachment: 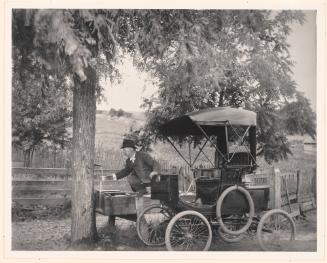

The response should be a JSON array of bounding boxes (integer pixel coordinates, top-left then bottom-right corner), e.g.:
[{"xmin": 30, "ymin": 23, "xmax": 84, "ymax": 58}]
[{"xmin": 165, "ymin": 210, "xmax": 212, "ymax": 251}]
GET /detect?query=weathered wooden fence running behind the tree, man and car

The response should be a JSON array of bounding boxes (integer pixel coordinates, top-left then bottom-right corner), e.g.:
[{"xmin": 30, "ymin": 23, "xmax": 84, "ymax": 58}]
[{"xmin": 12, "ymin": 168, "xmax": 316, "ymax": 216}]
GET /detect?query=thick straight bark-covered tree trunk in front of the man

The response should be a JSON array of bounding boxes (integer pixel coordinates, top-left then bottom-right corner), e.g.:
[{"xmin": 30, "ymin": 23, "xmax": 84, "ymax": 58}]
[{"xmin": 71, "ymin": 67, "xmax": 97, "ymax": 244}]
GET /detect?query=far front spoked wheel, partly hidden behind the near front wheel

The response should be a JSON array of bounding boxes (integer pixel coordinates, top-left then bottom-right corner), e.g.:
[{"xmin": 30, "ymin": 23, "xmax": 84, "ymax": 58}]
[{"xmin": 136, "ymin": 205, "xmax": 172, "ymax": 246}]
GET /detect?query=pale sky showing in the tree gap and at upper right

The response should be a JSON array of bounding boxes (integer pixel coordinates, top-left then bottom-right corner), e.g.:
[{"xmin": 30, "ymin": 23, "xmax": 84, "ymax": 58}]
[{"xmin": 98, "ymin": 10, "xmax": 316, "ymax": 111}]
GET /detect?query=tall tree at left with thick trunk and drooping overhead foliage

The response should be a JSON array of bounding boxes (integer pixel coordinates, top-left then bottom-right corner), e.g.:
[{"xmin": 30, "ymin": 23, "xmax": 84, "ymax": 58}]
[{"xmin": 13, "ymin": 9, "xmax": 228, "ymax": 242}]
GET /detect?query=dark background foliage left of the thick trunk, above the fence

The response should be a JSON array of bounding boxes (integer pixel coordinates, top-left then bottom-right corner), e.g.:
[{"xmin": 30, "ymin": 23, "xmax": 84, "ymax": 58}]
[{"xmin": 12, "ymin": 69, "xmax": 71, "ymax": 147}]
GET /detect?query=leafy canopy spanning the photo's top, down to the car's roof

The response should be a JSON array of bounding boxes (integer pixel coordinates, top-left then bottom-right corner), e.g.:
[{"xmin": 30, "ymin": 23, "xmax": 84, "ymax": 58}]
[{"xmin": 14, "ymin": 9, "xmax": 315, "ymax": 165}]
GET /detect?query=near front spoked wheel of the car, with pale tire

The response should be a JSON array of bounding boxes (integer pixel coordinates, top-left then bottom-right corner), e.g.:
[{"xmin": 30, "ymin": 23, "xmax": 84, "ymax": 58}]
[{"xmin": 165, "ymin": 210, "xmax": 212, "ymax": 251}]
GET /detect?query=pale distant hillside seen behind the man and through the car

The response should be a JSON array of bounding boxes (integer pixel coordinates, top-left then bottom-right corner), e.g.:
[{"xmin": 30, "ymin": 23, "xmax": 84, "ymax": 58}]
[{"xmin": 95, "ymin": 112, "xmax": 315, "ymax": 169}]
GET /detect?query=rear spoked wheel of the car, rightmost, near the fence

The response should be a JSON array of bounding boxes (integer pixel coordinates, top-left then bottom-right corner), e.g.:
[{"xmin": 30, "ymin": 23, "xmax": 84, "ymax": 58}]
[{"xmin": 257, "ymin": 209, "xmax": 296, "ymax": 251}]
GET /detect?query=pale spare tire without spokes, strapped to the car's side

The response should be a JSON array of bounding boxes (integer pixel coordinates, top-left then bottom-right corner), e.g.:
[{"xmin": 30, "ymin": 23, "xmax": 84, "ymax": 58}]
[{"xmin": 216, "ymin": 185, "xmax": 254, "ymax": 235}]
